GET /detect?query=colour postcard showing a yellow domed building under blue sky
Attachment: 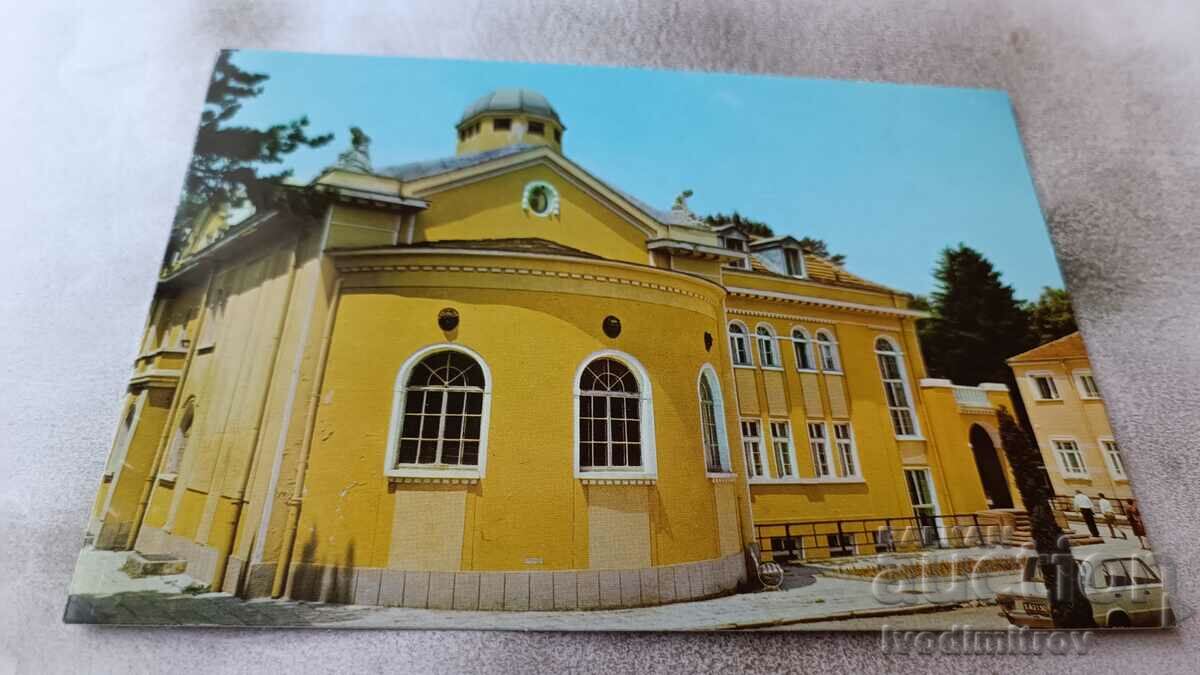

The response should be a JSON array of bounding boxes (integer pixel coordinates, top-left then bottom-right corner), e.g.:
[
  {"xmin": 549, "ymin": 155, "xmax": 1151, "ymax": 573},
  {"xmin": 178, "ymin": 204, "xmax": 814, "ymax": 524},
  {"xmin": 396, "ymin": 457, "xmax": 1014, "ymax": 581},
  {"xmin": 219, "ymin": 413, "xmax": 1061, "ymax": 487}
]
[{"xmin": 66, "ymin": 50, "xmax": 1175, "ymax": 634}]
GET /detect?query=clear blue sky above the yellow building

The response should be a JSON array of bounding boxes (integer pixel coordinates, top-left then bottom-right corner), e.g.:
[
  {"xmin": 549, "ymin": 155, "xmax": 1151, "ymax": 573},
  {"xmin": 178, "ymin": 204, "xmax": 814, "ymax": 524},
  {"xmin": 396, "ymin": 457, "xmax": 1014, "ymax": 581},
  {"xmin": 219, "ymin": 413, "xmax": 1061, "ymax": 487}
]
[{"xmin": 223, "ymin": 52, "xmax": 1062, "ymax": 299}]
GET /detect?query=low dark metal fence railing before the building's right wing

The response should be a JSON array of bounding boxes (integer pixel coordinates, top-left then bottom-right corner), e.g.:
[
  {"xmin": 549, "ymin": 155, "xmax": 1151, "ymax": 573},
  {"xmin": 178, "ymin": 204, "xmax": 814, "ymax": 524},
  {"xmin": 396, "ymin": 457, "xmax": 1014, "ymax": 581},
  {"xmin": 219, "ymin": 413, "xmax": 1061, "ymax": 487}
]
[{"xmin": 755, "ymin": 513, "xmax": 1010, "ymax": 563}]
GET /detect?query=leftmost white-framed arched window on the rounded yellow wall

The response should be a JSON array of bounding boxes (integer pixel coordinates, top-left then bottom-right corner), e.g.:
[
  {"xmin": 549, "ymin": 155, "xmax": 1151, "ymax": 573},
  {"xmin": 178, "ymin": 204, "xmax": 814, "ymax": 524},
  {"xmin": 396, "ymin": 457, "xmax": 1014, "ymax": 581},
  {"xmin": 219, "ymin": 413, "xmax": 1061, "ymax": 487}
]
[{"xmin": 386, "ymin": 345, "xmax": 491, "ymax": 476}]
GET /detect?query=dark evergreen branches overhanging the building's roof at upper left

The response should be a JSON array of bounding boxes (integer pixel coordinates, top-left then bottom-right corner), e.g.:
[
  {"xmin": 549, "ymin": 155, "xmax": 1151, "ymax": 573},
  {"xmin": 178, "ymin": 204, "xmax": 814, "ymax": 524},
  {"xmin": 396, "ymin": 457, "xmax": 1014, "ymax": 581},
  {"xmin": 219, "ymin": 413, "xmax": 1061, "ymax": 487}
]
[{"xmin": 168, "ymin": 50, "xmax": 334, "ymax": 256}]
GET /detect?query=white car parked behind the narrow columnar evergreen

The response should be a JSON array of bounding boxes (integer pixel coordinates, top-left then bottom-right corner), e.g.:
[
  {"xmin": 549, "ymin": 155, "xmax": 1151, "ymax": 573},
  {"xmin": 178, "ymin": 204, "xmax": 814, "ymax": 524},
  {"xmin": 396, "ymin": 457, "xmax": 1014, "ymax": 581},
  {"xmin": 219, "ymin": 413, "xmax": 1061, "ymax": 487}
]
[{"xmin": 996, "ymin": 556, "xmax": 1175, "ymax": 628}]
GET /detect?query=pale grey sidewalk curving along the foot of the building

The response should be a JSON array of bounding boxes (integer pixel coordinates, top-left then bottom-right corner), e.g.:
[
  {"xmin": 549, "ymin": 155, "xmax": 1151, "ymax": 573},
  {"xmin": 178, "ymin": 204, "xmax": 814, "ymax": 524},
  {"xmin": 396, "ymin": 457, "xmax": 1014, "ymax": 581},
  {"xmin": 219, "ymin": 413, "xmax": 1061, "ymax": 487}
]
[{"xmin": 66, "ymin": 549, "xmax": 1032, "ymax": 631}]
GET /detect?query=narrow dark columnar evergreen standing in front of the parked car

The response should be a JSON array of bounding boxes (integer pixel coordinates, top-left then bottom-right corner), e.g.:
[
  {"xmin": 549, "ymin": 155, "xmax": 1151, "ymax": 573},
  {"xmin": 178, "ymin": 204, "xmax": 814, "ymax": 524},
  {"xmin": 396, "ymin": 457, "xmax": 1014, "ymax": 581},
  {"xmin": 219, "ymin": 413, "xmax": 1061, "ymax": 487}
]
[{"xmin": 996, "ymin": 407, "xmax": 1096, "ymax": 628}]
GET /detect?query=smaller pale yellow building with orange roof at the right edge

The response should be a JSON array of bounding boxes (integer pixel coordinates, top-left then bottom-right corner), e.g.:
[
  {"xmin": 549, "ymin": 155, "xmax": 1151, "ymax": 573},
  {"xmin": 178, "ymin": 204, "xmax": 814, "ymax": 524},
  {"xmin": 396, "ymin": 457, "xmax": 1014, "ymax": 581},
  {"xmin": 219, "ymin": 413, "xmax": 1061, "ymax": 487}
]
[{"xmin": 1008, "ymin": 331, "xmax": 1133, "ymax": 498}]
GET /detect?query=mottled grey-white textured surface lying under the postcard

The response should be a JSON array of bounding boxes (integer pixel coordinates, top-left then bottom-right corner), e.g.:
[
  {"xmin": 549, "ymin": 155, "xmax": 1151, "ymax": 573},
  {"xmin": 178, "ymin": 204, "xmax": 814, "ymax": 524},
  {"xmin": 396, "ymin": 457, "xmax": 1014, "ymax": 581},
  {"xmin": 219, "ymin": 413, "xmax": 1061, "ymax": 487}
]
[{"xmin": 0, "ymin": 0, "xmax": 1200, "ymax": 673}]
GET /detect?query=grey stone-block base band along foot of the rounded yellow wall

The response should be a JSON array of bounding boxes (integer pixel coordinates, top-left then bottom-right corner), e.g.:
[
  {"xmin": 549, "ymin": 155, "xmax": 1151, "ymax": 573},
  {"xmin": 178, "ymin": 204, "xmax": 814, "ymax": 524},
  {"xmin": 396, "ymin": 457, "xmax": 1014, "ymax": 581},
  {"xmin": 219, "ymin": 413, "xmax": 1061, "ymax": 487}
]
[{"xmin": 286, "ymin": 552, "xmax": 746, "ymax": 611}]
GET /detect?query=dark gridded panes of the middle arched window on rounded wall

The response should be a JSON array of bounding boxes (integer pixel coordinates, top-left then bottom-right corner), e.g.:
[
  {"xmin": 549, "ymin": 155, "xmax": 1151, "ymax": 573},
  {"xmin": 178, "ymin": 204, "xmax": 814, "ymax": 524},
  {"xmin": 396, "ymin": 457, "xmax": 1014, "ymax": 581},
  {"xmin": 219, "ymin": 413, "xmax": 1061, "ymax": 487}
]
[{"xmin": 578, "ymin": 357, "xmax": 642, "ymax": 471}]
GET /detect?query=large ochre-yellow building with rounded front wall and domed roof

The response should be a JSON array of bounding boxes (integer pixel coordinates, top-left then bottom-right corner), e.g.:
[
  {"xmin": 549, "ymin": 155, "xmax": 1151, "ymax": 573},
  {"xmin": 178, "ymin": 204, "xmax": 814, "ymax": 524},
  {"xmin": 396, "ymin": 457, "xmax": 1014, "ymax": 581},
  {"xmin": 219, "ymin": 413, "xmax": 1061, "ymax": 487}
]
[{"xmin": 89, "ymin": 90, "xmax": 1012, "ymax": 610}]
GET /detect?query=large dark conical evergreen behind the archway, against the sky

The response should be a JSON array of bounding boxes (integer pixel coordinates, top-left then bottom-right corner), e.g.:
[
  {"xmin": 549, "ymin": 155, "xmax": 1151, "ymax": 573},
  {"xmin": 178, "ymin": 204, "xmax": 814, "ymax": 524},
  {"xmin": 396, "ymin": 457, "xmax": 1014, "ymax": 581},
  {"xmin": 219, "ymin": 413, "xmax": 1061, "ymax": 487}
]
[{"xmin": 919, "ymin": 244, "xmax": 1033, "ymax": 384}]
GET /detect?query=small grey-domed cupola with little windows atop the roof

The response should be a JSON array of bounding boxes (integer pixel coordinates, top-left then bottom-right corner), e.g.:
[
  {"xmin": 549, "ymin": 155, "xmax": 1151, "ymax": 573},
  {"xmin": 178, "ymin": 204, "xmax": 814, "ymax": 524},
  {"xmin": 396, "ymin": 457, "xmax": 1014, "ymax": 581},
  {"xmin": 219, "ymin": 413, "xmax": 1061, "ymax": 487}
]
[{"xmin": 455, "ymin": 89, "xmax": 566, "ymax": 155}]
